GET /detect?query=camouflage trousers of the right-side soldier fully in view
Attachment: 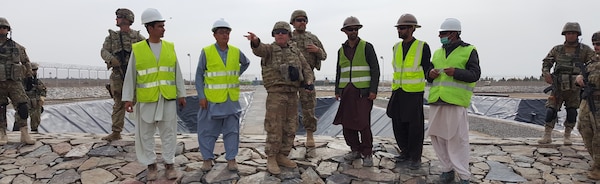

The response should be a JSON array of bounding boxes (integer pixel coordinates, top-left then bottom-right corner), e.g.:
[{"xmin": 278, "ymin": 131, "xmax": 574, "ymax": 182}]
[{"xmin": 544, "ymin": 88, "xmax": 581, "ymax": 129}]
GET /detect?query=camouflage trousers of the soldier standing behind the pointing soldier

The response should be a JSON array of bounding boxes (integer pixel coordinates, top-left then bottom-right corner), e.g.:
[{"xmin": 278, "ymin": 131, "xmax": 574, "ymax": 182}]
[{"xmin": 298, "ymin": 88, "xmax": 317, "ymax": 132}]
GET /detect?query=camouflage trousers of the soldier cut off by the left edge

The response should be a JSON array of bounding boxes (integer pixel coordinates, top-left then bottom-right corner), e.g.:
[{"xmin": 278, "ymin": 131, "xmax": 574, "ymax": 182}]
[{"xmin": 0, "ymin": 80, "xmax": 29, "ymax": 129}]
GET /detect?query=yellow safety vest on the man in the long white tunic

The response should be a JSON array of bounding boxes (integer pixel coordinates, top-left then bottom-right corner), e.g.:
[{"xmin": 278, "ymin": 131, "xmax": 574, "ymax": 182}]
[{"xmin": 132, "ymin": 40, "xmax": 177, "ymax": 102}]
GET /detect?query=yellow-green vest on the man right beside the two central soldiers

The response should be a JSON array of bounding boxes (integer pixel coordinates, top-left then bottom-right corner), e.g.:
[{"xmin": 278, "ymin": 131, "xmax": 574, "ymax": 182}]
[{"xmin": 338, "ymin": 40, "xmax": 371, "ymax": 88}]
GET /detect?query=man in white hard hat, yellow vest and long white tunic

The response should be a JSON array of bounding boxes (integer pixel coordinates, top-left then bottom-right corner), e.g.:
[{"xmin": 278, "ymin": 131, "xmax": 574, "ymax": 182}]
[{"xmin": 122, "ymin": 8, "xmax": 186, "ymax": 181}]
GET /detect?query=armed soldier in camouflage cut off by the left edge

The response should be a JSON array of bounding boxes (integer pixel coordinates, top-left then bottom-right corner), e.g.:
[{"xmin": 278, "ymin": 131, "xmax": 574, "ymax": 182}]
[{"xmin": 0, "ymin": 17, "xmax": 35, "ymax": 145}]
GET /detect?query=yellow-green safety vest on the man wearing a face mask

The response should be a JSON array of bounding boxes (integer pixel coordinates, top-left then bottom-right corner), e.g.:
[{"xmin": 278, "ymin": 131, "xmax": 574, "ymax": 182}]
[{"xmin": 427, "ymin": 45, "xmax": 475, "ymax": 107}]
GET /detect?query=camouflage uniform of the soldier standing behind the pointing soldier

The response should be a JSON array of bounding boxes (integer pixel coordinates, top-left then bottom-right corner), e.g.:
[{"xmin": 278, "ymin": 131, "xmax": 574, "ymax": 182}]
[{"xmin": 291, "ymin": 27, "xmax": 327, "ymax": 135}]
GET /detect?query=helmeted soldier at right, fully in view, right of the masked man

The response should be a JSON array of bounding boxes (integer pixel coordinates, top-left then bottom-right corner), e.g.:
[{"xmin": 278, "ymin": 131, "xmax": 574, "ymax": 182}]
[{"xmin": 538, "ymin": 22, "xmax": 595, "ymax": 145}]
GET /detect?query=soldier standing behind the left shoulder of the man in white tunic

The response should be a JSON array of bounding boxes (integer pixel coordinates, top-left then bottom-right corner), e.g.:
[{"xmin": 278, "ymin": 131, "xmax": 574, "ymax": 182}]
[{"xmin": 100, "ymin": 8, "xmax": 146, "ymax": 141}]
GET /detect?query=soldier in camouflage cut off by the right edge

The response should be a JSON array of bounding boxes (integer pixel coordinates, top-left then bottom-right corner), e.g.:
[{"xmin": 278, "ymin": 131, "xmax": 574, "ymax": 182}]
[{"xmin": 576, "ymin": 31, "xmax": 600, "ymax": 180}]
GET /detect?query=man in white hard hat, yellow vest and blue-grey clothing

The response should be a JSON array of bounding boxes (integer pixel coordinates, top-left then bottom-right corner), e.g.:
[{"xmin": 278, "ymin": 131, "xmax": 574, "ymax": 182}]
[{"xmin": 196, "ymin": 19, "xmax": 250, "ymax": 171}]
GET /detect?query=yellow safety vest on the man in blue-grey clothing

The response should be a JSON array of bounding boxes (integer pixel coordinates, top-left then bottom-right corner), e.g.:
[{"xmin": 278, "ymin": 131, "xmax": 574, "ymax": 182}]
[{"xmin": 204, "ymin": 44, "xmax": 240, "ymax": 103}]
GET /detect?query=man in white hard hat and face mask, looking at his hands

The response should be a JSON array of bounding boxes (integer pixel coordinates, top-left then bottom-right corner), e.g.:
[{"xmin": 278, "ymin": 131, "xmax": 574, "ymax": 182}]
[{"xmin": 427, "ymin": 18, "xmax": 481, "ymax": 183}]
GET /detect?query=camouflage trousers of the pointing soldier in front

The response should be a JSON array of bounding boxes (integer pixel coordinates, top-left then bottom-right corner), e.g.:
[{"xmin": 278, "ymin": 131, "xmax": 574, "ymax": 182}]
[{"xmin": 264, "ymin": 92, "xmax": 298, "ymax": 157}]
